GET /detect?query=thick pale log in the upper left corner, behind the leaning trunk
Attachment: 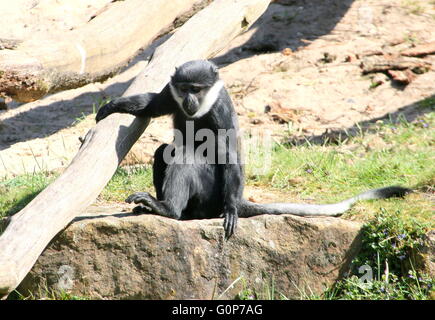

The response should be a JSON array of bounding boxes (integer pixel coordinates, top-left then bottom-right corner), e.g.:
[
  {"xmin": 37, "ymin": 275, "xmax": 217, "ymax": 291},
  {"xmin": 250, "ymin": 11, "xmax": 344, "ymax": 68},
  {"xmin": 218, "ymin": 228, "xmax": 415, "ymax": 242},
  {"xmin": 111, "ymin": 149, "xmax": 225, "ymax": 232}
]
[{"xmin": 0, "ymin": 0, "xmax": 204, "ymax": 102}]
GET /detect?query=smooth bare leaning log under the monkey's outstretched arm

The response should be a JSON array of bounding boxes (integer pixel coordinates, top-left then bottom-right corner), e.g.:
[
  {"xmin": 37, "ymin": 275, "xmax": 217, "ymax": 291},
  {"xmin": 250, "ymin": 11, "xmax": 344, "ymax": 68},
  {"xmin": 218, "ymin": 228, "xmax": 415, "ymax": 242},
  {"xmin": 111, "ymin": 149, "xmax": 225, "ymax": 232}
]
[{"xmin": 0, "ymin": 0, "xmax": 270, "ymax": 297}]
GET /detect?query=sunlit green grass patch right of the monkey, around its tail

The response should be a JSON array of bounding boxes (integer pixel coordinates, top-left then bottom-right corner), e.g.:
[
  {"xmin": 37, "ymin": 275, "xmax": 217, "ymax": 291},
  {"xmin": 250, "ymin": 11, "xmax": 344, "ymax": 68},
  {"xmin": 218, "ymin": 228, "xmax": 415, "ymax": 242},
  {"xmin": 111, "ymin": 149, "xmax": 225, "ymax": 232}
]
[{"xmin": 246, "ymin": 113, "xmax": 435, "ymax": 221}]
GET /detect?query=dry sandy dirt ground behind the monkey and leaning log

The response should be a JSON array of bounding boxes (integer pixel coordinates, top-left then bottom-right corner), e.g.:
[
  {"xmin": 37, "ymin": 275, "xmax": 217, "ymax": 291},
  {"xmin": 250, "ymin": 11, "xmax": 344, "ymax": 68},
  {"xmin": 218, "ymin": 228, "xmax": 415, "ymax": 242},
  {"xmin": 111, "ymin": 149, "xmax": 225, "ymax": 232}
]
[{"xmin": 0, "ymin": 0, "xmax": 435, "ymax": 190}]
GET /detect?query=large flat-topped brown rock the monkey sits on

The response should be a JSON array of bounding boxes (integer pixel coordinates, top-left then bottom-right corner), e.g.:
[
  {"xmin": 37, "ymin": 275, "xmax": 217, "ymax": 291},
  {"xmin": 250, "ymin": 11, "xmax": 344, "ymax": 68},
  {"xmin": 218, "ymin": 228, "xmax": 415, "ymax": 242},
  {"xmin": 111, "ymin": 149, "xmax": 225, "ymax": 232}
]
[{"xmin": 19, "ymin": 205, "xmax": 361, "ymax": 299}]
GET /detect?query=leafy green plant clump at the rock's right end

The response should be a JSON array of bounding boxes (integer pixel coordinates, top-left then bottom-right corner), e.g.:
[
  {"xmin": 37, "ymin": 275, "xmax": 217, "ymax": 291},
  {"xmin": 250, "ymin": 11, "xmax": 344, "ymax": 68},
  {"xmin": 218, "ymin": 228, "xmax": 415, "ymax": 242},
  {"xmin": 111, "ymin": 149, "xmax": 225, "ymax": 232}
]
[{"xmin": 308, "ymin": 210, "xmax": 435, "ymax": 300}]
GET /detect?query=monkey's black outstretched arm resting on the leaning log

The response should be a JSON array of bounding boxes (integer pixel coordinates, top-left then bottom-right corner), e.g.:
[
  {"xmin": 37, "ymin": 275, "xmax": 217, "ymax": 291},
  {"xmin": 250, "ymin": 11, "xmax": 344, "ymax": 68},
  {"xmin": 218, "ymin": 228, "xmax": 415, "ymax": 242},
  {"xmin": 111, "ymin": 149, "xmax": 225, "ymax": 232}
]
[{"xmin": 95, "ymin": 85, "xmax": 176, "ymax": 122}]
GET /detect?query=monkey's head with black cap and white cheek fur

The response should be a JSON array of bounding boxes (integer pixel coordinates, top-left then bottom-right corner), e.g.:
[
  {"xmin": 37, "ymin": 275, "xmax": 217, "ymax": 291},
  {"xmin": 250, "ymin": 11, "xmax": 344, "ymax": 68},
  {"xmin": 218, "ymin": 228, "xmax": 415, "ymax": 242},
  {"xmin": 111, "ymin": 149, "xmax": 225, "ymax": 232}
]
[{"xmin": 170, "ymin": 60, "xmax": 223, "ymax": 118}]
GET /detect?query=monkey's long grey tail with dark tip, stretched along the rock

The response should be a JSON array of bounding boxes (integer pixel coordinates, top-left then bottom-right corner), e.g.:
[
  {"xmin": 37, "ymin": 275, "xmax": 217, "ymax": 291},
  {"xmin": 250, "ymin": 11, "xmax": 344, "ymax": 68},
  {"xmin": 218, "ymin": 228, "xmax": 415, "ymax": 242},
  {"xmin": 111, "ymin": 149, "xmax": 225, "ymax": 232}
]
[{"xmin": 238, "ymin": 186, "xmax": 412, "ymax": 217}]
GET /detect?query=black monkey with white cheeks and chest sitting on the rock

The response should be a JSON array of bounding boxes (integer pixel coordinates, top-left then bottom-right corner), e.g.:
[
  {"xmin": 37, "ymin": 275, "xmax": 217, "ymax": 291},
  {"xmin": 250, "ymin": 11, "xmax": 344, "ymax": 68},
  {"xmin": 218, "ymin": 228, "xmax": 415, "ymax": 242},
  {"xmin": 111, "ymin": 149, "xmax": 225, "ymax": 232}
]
[{"xmin": 96, "ymin": 60, "xmax": 411, "ymax": 239}]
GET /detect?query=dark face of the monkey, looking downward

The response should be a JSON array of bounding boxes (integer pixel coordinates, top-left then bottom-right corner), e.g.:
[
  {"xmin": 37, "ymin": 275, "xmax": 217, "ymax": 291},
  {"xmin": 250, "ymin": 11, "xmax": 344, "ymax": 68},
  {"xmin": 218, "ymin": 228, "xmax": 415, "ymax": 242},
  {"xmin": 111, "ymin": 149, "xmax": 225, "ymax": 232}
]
[{"xmin": 173, "ymin": 82, "xmax": 209, "ymax": 117}]
